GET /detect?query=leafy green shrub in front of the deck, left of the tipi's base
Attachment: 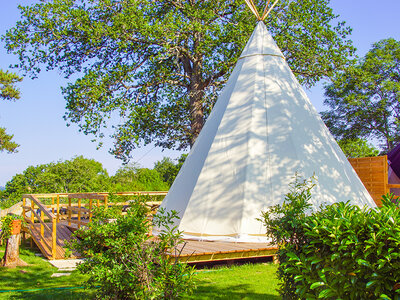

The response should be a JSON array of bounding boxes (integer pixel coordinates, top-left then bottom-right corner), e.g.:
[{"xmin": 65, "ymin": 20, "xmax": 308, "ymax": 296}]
[{"xmin": 69, "ymin": 201, "xmax": 193, "ymax": 299}]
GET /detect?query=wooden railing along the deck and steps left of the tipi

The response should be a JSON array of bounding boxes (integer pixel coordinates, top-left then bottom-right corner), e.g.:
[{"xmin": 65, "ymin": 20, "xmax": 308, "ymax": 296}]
[{"xmin": 22, "ymin": 191, "xmax": 167, "ymax": 259}]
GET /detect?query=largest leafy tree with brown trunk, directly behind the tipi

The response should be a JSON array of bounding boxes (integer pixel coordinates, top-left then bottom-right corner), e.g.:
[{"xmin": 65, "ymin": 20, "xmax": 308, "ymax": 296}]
[{"xmin": 4, "ymin": 0, "xmax": 354, "ymax": 159}]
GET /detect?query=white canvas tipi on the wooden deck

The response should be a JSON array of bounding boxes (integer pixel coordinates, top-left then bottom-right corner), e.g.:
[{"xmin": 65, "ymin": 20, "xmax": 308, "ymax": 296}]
[{"xmin": 154, "ymin": 22, "xmax": 375, "ymax": 242}]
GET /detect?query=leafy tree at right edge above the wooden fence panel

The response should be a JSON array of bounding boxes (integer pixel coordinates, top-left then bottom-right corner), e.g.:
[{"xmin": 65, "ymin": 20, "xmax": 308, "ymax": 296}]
[{"xmin": 322, "ymin": 38, "xmax": 400, "ymax": 151}]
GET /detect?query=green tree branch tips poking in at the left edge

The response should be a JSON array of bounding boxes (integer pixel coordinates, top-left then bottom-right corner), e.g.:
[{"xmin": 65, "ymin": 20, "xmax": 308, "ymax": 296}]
[{"xmin": 0, "ymin": 69, "xmax": 22, "ymax": 153}]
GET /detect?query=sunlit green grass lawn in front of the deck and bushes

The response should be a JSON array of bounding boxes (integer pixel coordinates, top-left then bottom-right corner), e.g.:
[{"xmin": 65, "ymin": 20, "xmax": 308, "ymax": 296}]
[{"xmin": 0, "ymin": 247, "xmax": 280, "ymax": 300}]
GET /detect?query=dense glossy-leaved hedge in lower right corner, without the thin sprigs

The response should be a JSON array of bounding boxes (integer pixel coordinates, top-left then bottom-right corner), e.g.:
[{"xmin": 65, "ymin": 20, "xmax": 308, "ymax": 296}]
[{"xmin": 290, "ymin": 202, "xmax": 400, "ymax": 299}]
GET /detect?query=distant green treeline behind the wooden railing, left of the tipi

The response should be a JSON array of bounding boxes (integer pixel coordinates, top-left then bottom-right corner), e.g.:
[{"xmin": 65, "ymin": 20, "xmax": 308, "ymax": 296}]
[{"xmin": 0, "ymin": 154, "xmax": 187, "ymax": 208}]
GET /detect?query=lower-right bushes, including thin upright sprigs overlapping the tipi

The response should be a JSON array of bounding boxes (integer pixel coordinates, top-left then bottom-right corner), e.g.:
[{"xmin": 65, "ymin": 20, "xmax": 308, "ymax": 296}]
[{"xmin": 264, "ymin": 176, "xmax": 400, "ymax": 299}]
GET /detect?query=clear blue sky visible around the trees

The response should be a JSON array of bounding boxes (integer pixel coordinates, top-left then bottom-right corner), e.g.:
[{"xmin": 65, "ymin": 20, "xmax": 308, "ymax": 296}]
[{"xmin": 0, "ymin": 0, "xmax": 400, "ymax": 186}]
